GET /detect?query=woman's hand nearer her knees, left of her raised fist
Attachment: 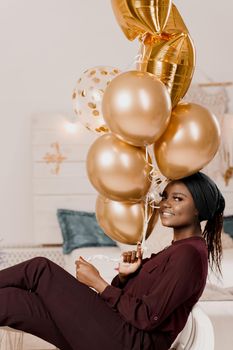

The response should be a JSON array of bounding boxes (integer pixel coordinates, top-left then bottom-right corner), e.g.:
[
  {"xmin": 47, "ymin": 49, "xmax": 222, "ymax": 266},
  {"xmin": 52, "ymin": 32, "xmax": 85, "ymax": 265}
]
[{"xmin": 75, "ymin": 256, "xmax": 108, "ymax": 293}]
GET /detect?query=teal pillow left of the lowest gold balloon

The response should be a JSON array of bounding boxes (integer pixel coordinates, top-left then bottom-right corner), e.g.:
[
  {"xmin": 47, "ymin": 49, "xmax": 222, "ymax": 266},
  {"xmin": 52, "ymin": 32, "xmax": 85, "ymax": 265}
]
[{"xmin": 57, "ymin": 209, "xmax": 116, "ymax": 254}]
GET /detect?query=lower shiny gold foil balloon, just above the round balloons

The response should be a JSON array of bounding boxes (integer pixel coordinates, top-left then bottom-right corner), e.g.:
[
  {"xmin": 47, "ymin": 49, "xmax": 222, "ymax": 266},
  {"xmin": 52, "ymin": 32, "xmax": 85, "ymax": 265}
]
[{"xmin": 137, "ymin": 33, "xmax": 195, "ymax": 107}]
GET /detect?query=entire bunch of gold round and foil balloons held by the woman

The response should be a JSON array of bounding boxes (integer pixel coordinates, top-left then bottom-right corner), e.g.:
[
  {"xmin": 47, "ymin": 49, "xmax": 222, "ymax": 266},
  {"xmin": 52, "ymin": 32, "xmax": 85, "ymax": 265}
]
[{"xmin": 74, "ymin": 0, "xmax": 220, "ymax": 244}]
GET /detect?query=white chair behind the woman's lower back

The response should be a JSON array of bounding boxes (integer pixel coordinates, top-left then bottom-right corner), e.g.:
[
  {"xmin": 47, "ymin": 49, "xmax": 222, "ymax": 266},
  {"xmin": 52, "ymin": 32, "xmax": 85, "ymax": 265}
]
[{"xmin": 170, "ymin": 305, "xmax": 214, "ymax": 350}]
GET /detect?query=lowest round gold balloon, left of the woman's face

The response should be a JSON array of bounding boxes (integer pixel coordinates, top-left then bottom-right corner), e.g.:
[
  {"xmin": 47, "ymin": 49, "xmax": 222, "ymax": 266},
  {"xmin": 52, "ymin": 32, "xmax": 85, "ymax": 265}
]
[{"xmin": 96, "ymin": 195, "xmax": 158, "ymax": 244}]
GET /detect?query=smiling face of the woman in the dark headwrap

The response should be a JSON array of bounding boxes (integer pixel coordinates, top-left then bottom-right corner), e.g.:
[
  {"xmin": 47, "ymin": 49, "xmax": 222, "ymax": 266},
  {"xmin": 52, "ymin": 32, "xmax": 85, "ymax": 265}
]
[{"xmin": 159, "ymin": 181, "xmax": 198, "ymax": 228}]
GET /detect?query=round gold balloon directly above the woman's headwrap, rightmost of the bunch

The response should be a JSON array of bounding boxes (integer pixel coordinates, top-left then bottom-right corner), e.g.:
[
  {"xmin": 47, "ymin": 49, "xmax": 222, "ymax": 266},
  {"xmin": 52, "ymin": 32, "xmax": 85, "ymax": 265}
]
[{"xmin": 154, "ymin": 103, "xmax": 220, "ymax": 180}]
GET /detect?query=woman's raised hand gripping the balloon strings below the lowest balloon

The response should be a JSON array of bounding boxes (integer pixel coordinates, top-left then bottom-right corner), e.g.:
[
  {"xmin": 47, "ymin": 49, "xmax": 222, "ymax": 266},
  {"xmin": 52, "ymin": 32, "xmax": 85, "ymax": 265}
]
[{"xmin": 119, "ymin": 242, "xmax": 142, "ymax": 282}]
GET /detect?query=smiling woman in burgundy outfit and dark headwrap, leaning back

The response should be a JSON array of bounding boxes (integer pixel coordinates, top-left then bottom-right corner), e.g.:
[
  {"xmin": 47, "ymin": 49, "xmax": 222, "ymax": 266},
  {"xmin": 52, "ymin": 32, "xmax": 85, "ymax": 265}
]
[{"xmin": 0, "ymin": 173, "xmax": 225, "ymax": 350}]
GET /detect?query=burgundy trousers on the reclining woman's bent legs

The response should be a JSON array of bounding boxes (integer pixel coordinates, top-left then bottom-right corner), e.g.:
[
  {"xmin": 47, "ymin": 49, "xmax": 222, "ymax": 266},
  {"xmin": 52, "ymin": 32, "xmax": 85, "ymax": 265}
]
[{"xmin": 0, "ymin": 257, "xmax": 137, "ymax": 350}]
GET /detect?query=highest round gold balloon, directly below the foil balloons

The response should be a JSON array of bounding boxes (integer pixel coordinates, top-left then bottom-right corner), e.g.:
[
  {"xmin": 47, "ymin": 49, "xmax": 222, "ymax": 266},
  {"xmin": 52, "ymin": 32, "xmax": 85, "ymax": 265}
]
[{"xmin": 102, "ymin": 71, "xmax": 171, "ymax": 146}]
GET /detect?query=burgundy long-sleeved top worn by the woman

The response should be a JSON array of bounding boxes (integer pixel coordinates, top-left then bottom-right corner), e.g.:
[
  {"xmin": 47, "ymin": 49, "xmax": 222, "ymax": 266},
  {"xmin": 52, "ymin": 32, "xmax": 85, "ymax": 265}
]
[{"xmin": 101, "ymin": 237, "xmax": 208, "ymax": 350}]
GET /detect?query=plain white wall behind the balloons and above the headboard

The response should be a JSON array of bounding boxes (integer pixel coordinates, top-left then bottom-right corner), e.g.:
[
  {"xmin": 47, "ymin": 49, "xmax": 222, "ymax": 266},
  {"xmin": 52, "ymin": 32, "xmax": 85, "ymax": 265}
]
[{"xmin": 0, "ymin": 0, "xmax": 233, "ymax": 244}]
